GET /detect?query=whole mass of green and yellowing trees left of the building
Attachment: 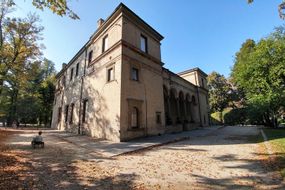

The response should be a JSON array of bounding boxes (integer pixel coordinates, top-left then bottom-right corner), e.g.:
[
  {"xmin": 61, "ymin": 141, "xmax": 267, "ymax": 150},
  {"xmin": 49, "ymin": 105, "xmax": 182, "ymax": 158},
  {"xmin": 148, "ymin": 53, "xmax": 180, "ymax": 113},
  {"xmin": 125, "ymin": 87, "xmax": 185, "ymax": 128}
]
[{"xmin": 0, "ymin": 0, "xmax": 55, "ymax": 125}]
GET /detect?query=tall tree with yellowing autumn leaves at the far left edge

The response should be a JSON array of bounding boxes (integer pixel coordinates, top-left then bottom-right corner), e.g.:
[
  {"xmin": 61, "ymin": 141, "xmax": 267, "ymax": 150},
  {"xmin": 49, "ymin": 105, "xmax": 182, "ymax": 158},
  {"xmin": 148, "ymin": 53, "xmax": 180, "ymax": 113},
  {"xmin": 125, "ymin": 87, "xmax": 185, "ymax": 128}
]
[{"xmin": 0, "ymin": 0, "xmax": 43, "ymax": 122}]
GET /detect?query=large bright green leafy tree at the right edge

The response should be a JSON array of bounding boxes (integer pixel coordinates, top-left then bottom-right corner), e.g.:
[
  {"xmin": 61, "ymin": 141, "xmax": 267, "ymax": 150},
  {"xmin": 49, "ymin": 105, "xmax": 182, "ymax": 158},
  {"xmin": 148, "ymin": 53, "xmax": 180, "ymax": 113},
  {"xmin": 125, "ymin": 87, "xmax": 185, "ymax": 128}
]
[{"xmin": 232, "ymin": 27, "xmax": 285, "ymax": 127}]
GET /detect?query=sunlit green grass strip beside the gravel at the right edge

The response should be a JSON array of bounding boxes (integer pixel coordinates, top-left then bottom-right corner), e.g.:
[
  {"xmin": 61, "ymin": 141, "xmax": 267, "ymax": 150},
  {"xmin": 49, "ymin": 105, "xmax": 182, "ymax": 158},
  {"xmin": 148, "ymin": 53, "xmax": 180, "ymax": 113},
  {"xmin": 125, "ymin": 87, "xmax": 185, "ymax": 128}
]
[{"xmin": 263, "ymin": 128, "xmax": 285, "ymax": 178}]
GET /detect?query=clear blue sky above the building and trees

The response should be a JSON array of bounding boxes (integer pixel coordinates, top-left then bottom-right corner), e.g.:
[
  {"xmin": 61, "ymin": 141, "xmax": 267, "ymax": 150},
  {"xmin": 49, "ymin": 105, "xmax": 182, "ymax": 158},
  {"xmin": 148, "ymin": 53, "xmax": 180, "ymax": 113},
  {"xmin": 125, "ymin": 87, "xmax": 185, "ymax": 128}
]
[{"xmin": 12, "ymin": 0, "xmax": 285, "ymax": 77}]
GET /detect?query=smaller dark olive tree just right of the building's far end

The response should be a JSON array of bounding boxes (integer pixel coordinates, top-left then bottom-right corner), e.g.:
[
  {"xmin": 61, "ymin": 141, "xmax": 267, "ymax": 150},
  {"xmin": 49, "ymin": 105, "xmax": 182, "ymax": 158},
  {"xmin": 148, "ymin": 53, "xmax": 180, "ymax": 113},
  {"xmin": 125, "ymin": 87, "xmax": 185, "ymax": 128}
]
[{"xmin": 207, "ymin": 72, "xmax": 231, "ymax": 121}]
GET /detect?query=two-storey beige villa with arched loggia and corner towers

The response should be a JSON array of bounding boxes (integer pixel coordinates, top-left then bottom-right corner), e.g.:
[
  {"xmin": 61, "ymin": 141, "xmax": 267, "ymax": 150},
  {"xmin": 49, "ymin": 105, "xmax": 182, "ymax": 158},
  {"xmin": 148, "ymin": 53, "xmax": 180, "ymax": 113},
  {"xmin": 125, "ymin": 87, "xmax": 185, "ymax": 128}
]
[{"xmin": 52, "ymin": 4, "xmax": 209, "ymax": 141}]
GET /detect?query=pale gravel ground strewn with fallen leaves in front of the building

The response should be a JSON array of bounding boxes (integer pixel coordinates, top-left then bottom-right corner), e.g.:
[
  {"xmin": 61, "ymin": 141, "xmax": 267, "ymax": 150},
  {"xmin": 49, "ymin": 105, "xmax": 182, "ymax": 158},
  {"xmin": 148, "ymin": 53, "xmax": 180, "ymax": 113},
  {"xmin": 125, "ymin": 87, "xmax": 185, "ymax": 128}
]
[{"xmin": 0, "ymin": 127, "xmax": 285, "ymax": 190}]
